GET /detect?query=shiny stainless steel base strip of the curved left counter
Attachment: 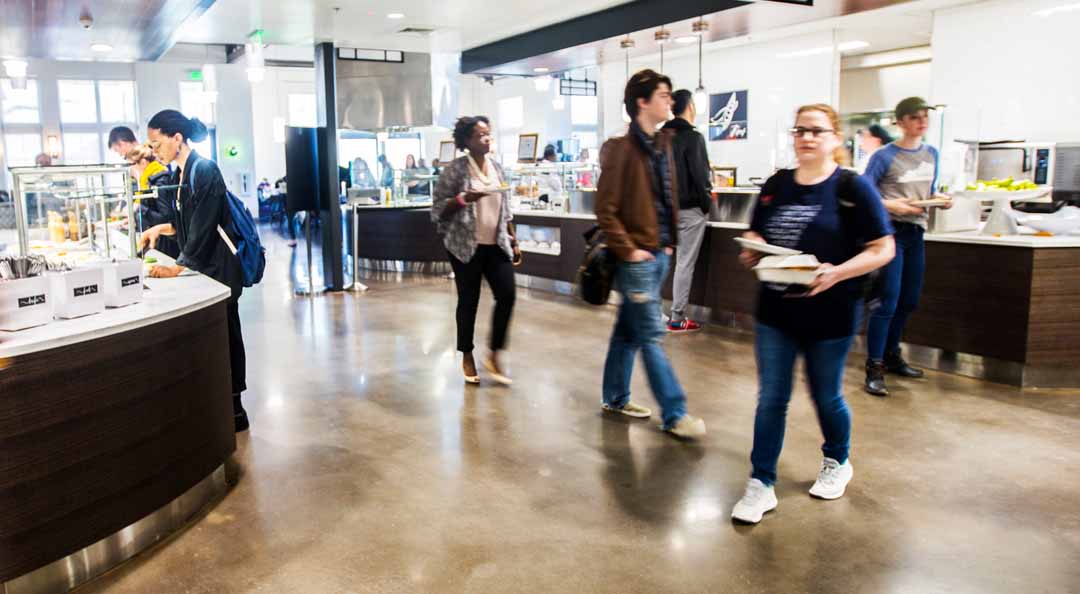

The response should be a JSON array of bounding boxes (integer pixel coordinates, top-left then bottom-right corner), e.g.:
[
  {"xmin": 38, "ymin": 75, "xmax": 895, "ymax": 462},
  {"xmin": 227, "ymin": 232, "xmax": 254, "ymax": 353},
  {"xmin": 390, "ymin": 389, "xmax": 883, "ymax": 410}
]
[{"xmin": 0, "ymin": 464, "xmax": 228, "ymax": 594}]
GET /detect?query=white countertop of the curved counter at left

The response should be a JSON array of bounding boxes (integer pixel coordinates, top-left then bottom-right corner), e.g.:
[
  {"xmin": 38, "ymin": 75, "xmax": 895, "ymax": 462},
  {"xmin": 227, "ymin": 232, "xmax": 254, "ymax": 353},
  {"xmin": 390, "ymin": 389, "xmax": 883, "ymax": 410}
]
[{"xmin": 0, "ymin": 252, "xmax": 230, "ymax": 360}]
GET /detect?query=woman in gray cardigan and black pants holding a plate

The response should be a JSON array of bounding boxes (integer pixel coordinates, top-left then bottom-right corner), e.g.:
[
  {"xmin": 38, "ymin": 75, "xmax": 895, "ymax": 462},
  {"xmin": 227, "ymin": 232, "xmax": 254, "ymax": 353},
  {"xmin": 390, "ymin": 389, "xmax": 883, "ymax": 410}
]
[{"xmin": 431, "ymin": 116, "xmax": 521, "ymax": 386}]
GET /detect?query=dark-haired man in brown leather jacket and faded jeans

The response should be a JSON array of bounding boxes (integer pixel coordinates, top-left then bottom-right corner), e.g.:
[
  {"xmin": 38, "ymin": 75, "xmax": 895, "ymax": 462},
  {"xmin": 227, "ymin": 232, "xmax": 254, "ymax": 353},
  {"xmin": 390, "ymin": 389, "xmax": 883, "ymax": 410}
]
[{"xmin": 596, "ymin": 70, "xmax": 705, "ymax": 437}]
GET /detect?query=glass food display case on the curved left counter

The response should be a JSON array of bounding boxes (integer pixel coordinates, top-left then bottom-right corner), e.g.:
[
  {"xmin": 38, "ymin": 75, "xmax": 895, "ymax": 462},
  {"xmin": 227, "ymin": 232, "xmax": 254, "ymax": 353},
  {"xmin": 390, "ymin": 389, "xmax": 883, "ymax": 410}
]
[{"xmin": 0, "ymin": 164, "xmax": 141, "ymax": 266}]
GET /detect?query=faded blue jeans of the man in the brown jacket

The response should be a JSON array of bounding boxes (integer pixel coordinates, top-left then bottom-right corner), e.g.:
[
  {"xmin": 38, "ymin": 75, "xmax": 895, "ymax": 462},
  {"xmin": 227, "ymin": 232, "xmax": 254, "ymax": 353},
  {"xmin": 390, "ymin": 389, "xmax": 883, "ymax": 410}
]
[{"xmin": 604, "ymin": 251, "xmax": 686, "ymax": 429}]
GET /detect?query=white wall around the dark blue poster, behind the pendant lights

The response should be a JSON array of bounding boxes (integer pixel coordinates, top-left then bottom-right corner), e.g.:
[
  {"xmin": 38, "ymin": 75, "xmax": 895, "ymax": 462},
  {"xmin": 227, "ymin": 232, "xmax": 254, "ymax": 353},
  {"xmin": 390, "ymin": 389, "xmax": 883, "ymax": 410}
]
[{"xmin": 600, "ymin": 32, "xmax": 839, "ymax": 184}]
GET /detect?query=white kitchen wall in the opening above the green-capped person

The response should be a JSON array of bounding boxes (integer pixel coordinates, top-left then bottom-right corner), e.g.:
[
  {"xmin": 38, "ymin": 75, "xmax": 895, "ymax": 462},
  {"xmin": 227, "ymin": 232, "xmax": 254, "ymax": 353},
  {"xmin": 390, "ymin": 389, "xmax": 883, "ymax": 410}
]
[{"xmin": 840, "ymin": 62, "xmax": 932, "ymax": 113}]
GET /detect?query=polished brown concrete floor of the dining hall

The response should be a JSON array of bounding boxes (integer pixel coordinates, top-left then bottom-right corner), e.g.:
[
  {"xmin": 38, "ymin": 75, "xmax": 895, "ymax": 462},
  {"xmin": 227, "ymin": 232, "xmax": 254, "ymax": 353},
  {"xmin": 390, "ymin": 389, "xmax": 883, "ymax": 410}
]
[{"xmin": 80, "ymin": 232, "xmax": 1080, "ymax": 594}]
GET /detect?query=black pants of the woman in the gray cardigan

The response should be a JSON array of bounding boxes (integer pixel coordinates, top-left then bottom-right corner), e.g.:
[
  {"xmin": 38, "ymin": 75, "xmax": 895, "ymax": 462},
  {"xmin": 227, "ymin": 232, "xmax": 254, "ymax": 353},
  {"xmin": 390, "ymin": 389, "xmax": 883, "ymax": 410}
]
[{"xmin": 450, "ymin": 245, "xmax": 517, "ymax": 353}]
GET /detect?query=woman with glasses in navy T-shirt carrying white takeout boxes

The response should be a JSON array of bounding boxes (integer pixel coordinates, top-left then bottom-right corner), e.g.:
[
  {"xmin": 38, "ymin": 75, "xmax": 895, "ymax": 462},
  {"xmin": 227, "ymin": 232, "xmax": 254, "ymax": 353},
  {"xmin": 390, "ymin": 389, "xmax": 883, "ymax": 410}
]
[{"xmin": 731, "ymin": 105, "xmax": 894, "ymax": 524}]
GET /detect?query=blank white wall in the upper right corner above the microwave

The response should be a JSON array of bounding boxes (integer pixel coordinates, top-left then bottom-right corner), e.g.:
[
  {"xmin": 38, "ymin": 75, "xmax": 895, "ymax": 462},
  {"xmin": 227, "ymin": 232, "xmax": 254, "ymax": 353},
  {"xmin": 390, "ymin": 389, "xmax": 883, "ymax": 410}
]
[{"xmin": 930, "ymin": 0, "xmax": 1080, "ymax": 141}]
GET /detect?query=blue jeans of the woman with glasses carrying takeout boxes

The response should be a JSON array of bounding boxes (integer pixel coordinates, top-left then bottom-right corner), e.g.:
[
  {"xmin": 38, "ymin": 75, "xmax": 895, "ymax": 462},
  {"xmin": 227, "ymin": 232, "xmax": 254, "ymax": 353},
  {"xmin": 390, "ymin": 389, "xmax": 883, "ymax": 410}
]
[{"xmin": 750, "ymin": 324, "xmax": 852, "ymax": 485}]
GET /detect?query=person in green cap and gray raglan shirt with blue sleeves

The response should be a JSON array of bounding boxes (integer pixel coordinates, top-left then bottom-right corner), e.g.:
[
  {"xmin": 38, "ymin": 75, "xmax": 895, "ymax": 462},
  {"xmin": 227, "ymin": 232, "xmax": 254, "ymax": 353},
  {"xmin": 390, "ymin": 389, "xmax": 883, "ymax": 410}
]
[{"xmin": 864, "ymin": 97, "xmax": 951, "ymax": 396}]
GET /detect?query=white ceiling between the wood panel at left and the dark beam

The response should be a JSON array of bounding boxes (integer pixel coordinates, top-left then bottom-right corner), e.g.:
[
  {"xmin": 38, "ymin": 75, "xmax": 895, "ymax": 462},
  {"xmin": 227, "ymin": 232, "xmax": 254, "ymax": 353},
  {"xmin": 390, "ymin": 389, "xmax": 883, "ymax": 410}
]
[{"xmin": 177, "ymin": 0, "xmax": 635, "ymax": 51}]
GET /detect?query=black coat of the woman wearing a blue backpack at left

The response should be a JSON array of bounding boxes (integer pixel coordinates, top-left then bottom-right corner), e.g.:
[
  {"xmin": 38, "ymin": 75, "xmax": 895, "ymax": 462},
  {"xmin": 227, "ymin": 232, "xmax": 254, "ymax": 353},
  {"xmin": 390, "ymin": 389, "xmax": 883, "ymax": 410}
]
[{"xmin": 173, "ymin": 151, "xmax": 244, "ymax": 294}]
